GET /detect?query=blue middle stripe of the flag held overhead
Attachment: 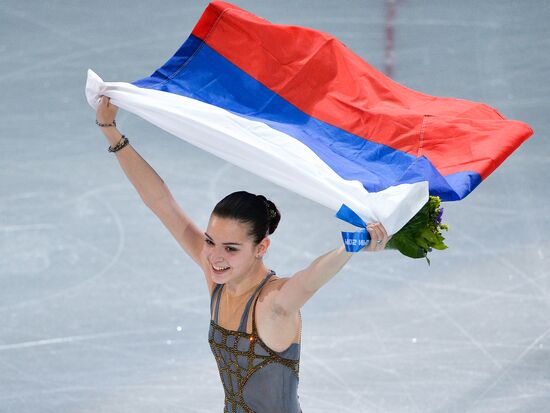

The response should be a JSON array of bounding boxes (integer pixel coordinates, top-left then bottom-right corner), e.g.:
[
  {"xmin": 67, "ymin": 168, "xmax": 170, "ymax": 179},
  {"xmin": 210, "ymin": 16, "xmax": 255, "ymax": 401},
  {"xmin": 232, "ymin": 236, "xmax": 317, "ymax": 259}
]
[{"xmin": 132, "ymin": 35, "xmax": 481, "ymax": 201}]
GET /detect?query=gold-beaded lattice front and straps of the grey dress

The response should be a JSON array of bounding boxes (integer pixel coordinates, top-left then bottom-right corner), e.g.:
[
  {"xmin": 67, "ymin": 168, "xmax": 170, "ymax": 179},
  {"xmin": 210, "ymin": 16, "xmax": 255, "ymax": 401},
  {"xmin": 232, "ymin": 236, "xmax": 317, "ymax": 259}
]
[{"xmin": 208, "ymin": 271, "xmax": 300, "ymax": 413}]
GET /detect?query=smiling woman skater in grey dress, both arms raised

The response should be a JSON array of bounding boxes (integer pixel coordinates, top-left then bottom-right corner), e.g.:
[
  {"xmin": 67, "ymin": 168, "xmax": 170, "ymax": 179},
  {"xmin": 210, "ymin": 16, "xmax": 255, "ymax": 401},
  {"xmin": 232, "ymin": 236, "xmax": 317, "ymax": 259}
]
[{"xmin": 96, "ymin": 96, "xmax": 390, "ymax": 413}]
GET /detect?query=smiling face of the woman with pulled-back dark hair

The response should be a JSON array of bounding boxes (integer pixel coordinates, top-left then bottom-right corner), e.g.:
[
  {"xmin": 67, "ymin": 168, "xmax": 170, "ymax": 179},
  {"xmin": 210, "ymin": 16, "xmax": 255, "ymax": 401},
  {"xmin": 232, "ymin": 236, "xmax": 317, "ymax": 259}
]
[{"xmin": 202, "ymin": 215, "xmax": 265, "ymax": 284}]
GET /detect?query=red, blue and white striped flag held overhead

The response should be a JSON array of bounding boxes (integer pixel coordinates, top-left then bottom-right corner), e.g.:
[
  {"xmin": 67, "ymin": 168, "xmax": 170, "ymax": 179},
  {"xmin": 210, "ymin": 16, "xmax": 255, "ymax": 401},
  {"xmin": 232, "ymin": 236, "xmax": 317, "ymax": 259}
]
[{"xmin": 86, "ymin": 1, "xmax": 533, "ymax": 234}]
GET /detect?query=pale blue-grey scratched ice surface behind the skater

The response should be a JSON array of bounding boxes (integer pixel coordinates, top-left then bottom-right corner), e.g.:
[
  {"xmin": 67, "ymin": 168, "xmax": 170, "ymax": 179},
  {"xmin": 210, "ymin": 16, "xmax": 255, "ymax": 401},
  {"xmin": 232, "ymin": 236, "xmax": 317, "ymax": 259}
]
[{"xmin": 0, "ymin": 0, "xmax": 550, "ymax": 413}]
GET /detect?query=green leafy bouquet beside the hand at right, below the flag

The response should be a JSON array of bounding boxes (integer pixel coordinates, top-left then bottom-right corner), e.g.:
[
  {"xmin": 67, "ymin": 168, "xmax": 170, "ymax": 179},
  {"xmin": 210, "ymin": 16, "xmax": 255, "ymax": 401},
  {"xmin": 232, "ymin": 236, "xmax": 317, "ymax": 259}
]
[{"xmin": 386, "ymin": 195, "xmax": 449, "ymax": 265}]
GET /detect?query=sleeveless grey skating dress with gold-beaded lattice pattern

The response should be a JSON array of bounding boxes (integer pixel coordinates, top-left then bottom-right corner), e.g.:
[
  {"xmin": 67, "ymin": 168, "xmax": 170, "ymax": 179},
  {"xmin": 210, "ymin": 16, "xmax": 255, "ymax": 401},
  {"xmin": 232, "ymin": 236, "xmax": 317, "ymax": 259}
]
[{"xmin": 208, "ymin": 270, "xmax": 301, "ymax": 413}]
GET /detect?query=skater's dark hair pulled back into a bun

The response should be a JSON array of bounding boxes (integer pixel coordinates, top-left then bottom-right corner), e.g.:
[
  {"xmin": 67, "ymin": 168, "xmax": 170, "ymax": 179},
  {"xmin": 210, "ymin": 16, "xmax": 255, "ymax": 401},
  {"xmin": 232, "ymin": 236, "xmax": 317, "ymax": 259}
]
[{"xmin": 212, "ymin": 191, "xmax": 281, "ymax": 245}]
